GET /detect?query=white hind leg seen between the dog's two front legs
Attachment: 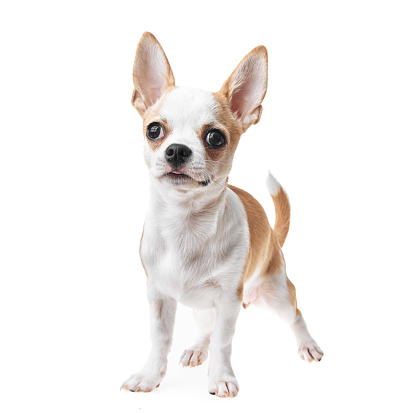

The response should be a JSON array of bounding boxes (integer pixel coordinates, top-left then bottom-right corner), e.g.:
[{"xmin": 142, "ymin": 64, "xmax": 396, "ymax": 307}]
[{"xmin": 180, "ymin": 308, "xmax": 215, "ymax": 367}]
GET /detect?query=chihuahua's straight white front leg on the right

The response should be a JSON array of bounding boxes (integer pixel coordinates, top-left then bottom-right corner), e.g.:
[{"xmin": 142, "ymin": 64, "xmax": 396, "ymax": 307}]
[{"xmin": 208, "ymin": 297, "xmax": 241, "ymax": 397}]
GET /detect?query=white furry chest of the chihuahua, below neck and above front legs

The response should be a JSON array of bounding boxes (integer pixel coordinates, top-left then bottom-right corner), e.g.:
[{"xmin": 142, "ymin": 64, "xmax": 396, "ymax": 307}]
[{"xmin": 141, "ymin": 191, "xmax": 249, "ymax": 308}]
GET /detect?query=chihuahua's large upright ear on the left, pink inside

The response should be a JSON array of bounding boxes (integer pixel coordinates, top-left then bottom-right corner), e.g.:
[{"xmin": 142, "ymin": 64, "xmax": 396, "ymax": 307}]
[{"xmin": 131, "ymin": 32, "xmax": 175, "ymax": 117}]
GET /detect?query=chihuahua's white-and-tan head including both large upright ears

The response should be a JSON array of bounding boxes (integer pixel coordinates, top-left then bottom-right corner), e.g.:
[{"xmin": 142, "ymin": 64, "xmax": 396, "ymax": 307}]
[{"xmin": 132, "ymin": 33, "xmax": 267, "ymax": 190}]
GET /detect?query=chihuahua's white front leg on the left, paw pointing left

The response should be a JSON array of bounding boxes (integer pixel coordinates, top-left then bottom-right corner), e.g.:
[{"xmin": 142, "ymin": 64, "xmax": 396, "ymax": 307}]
[{"xmin": 121, "ymin": 280, "xmax": 177, "ymax": 392}]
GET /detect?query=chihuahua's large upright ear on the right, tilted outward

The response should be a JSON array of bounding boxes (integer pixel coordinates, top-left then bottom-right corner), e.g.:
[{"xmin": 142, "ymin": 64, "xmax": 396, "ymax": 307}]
[{"xmin": 219, "ymin": 46, "xmax": 267, "ymax": 131}]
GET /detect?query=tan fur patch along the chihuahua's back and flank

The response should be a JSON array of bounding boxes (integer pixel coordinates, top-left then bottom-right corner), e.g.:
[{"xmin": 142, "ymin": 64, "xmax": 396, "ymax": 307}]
[{"xmin": 228, "ymin": 185, "xmax": 283, "ymax": 299}]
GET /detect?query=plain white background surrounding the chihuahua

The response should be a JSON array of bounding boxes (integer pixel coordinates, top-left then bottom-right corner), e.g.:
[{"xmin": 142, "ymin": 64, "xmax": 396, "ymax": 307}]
[{"xmin": 0, "ymin": 0, "xmax": 416, "ymax": 413}]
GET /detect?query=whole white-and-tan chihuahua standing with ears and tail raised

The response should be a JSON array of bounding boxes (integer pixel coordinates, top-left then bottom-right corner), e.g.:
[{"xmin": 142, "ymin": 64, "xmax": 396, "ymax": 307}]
[{"xmin": 122, "ymin": 33, "xmax": 323, "ymax": 397}]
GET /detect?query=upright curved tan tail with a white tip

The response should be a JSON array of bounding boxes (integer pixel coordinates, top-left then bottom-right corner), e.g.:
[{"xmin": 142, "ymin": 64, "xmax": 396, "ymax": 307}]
[{"xmin": 267, "ymin": 171, "xmax": 290, "ymax": 247}]
